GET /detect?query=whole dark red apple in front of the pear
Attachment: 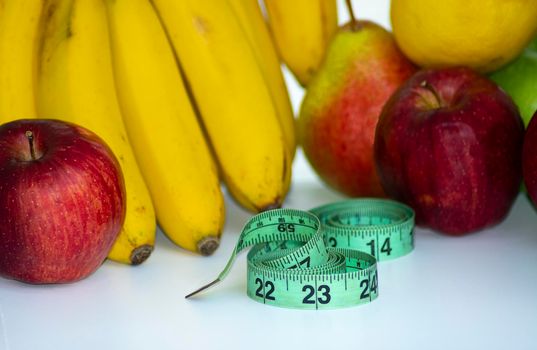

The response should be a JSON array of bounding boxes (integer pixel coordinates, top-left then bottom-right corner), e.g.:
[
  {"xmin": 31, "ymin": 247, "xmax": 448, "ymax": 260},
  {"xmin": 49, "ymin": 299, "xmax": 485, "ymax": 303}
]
[{"xmin": 374, "ymin": 68, "xmax": 524, "ymax": 235}]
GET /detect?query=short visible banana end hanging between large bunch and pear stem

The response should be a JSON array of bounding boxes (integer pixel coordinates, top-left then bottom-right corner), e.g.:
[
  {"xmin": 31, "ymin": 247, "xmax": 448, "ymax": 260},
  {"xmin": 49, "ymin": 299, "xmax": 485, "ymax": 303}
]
[{"xmin": 264, "ymin": 0, "xmax": 338, "ymax": 86}]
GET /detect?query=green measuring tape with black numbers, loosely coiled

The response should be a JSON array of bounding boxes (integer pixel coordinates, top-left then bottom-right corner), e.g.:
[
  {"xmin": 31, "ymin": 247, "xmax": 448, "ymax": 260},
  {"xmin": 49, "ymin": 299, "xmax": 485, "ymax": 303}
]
[{"xmin": 186, "ymin": 199, "xmax": 414, "ymax": 309}]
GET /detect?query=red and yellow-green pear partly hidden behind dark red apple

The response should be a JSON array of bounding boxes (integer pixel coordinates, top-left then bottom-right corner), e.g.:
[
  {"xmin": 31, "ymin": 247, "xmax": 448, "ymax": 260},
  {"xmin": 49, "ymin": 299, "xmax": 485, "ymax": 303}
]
[{"xmin": 298, "ymin": 17, "xmax": 415, "ymax": 197}]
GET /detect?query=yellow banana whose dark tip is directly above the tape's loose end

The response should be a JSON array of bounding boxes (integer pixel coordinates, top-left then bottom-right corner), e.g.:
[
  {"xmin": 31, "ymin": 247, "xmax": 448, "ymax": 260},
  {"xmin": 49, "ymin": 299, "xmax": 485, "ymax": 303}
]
[{"xmin": 105, "ymin": 0, "xmax": 224, "ymax": 255}]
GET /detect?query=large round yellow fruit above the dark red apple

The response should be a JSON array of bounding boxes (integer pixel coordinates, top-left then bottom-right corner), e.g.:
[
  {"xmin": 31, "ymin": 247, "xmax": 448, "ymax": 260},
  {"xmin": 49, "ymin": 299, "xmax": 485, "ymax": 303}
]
[{"xmin": 390, "ymin": 0, "xmax": 537, "ymax": 72}]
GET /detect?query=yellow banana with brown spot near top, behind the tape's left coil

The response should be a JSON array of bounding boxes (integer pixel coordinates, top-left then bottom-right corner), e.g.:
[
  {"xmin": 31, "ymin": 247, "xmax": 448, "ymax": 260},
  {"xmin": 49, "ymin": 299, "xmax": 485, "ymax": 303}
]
[{"xmin": 152, "ymin": 0, "xmax": 291, "ymax": 212}]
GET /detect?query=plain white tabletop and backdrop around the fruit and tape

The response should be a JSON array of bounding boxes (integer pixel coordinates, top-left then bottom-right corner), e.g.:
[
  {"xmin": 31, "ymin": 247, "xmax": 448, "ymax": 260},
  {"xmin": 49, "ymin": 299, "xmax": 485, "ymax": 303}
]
[{"xmin": 0, "ymin": 0, "xmax": 537, "ymax": 350}]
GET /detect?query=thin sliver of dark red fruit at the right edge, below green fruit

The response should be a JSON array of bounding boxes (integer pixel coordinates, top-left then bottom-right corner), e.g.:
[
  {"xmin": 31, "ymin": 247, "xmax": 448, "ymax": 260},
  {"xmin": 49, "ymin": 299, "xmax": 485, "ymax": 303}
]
[{"xmin": 522, "ymin": 111, "xmax": 537, "ymax": 207}]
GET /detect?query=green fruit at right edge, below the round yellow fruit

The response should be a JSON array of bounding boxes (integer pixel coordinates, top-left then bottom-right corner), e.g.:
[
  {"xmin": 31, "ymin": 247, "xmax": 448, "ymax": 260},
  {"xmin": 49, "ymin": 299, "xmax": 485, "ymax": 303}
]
[{"xmin": 490, "ymin": 37, "xmax": 537, "ymax": 126}]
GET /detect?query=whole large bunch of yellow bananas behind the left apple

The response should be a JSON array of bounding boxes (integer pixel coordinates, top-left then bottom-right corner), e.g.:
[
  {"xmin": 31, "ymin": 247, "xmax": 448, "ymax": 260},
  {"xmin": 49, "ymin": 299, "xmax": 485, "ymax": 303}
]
[{"xmin": 0, "ymin": 0, "xmax": 320, "ymax": 265}]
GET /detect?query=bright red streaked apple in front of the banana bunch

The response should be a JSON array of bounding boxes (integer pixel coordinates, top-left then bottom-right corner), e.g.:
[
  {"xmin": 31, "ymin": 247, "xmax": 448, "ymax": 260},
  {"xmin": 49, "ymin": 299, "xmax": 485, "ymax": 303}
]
[{"xmin": 0, "ymin": 120, "xmax": 125, "ymax": 283}]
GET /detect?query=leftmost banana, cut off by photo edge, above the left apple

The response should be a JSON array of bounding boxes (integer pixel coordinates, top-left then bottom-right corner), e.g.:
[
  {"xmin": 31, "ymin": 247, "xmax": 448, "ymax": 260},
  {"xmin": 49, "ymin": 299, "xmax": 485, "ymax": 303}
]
[{"xmin": 0, "ymin": 0, "xmax": 43, "ymax": 124}]
